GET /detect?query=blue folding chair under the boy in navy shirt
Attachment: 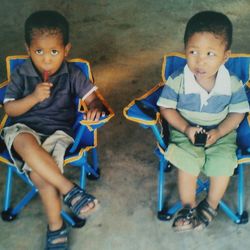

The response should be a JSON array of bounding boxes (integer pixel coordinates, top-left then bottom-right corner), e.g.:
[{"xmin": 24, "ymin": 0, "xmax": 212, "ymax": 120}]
[{"xmin": 0, "ymin": 56, "xmax": 114, "ymax": 227}]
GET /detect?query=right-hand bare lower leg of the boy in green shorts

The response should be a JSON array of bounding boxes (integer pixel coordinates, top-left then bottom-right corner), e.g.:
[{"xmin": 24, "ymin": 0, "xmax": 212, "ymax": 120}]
[{"xmin": 207, "ymin": 176, "xmax": 230, "ymax": 209}]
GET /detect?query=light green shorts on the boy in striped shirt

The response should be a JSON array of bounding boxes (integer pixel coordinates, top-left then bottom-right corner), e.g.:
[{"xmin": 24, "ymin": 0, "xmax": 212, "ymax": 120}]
[{"xmin": 164, "ymin": 129, "xmax": 237, "ymax": 176}]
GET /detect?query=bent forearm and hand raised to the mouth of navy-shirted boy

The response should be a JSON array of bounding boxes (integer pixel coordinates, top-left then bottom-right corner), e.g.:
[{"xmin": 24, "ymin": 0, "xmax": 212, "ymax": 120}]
[{"xmin": 4, "ymin": 82, "xmax": 52, "ymax": 117}]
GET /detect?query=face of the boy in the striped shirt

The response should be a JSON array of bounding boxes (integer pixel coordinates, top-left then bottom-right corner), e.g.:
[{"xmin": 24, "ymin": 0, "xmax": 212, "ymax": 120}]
[{"xmin": 185, "ymin": 32, "xmax": 230, "ymax": 84}]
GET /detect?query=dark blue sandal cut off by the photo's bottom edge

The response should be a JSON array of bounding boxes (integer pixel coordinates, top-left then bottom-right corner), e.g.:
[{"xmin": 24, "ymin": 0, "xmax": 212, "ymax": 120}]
[{"xmin": 45, "ymin": 223, "xmax": 68, "ymax": 250}]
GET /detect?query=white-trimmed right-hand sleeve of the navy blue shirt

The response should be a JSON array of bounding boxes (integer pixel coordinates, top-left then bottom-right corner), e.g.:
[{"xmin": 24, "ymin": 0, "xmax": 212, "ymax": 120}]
[{"xmin": 71, "ymin": 68, "xmax": 97, "ymax": 100}]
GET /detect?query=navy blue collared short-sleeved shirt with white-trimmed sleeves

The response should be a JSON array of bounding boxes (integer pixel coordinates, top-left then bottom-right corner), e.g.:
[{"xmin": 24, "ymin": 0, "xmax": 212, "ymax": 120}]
[{"xmin": 4, "ymin": 59, "xmax": 96, "ymax": 136}]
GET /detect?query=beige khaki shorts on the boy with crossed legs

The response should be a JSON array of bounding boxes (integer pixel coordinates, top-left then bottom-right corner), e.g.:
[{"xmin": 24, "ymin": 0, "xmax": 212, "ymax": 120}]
[{"xmin": 1, "ymin": 123, "xmax": 74, "ymax": 173}]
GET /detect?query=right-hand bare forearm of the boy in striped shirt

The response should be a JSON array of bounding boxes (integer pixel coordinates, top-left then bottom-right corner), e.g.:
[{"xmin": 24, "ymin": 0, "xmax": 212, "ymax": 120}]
[{"xmin": 206, "ymin": 113, "xmax": 245, "ymax": 147}]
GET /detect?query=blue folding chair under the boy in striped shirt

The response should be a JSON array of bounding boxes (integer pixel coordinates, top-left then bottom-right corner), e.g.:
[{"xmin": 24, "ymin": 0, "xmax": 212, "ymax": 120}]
[{"xmin": 123, "ymin": 53, "xmax": 250, "ymax": 224}]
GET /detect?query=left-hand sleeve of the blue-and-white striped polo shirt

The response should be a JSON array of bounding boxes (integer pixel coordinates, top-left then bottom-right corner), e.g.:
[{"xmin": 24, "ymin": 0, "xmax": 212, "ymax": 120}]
[{"xmin": 157, "ymin": 76, "xmax": 180, "ymax": 109}]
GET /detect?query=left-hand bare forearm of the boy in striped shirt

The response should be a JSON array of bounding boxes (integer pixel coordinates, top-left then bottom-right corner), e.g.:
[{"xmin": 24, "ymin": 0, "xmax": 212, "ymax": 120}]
[{"xmin": 160, "ymin": 107, "xmax": 202, "ymax": 143}]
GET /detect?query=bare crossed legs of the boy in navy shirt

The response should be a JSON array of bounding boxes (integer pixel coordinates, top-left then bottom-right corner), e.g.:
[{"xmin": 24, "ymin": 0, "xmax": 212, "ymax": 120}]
[{"xmin": 13, "ymin": 133, "xmax": 95, "ymax": 217}]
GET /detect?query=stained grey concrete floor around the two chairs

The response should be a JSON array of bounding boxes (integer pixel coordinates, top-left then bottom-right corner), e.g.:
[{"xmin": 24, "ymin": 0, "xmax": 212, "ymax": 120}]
[{"xmin": 0, "ymin": 0, "xmax": 250, "ymax": 250}]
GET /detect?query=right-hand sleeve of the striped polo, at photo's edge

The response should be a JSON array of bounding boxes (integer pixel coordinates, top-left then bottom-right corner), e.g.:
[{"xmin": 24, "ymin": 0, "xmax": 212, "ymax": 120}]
[{"xmin": 229, "ymin": 77, "xmax": 249, "ymax": 113}]
